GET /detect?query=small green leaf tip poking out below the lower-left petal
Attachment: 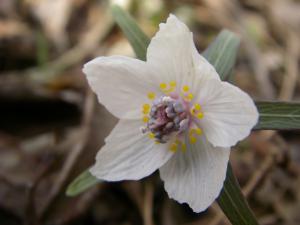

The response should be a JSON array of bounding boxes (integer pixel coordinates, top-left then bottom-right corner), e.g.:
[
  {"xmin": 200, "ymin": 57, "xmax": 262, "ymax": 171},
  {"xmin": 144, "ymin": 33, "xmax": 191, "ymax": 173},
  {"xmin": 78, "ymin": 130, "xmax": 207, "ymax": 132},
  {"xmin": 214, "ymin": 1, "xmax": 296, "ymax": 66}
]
[{"xmin": 66, "ymin": 170, "xmax": 100, "ymax": 197}]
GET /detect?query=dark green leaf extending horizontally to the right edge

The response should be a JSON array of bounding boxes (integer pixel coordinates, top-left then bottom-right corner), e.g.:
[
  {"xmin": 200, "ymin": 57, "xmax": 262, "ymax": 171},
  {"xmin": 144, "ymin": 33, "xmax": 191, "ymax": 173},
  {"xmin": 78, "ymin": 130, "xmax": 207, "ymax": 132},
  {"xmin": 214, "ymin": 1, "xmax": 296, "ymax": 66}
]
[{"xmin": 254, "ymin": 102, "xmax": 300, "ymax": 130}]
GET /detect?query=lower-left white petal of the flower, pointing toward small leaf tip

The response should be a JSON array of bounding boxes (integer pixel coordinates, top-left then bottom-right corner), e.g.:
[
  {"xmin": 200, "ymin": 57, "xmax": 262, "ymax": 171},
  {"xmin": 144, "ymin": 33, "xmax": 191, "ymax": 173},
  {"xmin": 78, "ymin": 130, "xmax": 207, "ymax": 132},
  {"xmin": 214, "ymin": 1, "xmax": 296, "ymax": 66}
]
[{"xmin": 90, "ymin": 120, "xmax": 173, "ymax": 181}]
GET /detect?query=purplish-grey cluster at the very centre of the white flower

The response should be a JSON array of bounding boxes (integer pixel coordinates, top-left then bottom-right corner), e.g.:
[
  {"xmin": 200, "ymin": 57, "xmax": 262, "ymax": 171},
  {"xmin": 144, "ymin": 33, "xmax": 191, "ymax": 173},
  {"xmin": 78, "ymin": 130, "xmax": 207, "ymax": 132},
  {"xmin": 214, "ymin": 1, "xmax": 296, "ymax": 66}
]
[{"xmin": 143, "ymin": 96, "xmax": 189, "ymax": 143}]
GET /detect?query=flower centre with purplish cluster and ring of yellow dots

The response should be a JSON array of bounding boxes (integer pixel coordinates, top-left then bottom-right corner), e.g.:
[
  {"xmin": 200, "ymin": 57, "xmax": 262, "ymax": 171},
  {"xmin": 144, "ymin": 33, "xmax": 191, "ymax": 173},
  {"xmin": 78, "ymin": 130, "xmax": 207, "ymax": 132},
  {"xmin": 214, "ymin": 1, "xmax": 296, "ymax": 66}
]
[{"xmin": 141, "ymin": 81, "xmax": 204, "ymax": 152}]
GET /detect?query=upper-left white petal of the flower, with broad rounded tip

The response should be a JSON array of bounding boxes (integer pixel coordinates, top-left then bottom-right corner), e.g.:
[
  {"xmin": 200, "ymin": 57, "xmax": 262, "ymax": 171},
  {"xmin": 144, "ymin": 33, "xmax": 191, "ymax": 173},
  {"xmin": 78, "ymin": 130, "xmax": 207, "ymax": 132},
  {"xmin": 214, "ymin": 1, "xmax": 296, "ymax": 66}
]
[{"xmin": 83, "ymin": 56, "xmax": 158, "ymax": 119}]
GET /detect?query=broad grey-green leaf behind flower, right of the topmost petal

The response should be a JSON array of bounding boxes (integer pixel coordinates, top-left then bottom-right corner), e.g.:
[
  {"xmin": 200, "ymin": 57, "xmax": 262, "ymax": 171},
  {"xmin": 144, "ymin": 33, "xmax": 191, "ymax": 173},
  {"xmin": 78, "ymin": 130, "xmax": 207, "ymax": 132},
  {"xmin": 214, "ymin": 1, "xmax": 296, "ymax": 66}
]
[{"xmin": 202, "ymin": 30, "xmax": 240, "ymax": 80}]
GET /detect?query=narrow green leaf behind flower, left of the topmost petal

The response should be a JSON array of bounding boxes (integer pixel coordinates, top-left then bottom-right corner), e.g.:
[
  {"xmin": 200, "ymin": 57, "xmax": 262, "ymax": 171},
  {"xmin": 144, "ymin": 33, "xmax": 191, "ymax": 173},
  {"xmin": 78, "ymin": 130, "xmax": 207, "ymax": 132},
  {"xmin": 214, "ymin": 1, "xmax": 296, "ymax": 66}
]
[{"xmin": 112, "ymin": 5, "xmax": 150, "ymax": 60}]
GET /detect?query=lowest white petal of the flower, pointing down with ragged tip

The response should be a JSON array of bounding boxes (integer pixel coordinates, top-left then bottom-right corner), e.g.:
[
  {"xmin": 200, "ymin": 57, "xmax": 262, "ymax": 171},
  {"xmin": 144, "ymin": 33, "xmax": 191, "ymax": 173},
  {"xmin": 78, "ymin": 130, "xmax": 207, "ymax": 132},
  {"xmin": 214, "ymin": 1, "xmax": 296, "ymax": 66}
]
[{"xmin": 160, "ymin": 137, "xmax": 230, "ymax": 212}]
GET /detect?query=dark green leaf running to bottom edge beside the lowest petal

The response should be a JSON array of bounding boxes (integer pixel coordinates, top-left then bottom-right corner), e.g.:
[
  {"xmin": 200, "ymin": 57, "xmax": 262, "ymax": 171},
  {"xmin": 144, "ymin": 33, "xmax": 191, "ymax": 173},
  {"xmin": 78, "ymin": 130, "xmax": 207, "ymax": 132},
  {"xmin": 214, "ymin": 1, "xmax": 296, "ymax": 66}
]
[{"xmin": 217, "ymin": 164, "xmax": 258, "ymax": 225}]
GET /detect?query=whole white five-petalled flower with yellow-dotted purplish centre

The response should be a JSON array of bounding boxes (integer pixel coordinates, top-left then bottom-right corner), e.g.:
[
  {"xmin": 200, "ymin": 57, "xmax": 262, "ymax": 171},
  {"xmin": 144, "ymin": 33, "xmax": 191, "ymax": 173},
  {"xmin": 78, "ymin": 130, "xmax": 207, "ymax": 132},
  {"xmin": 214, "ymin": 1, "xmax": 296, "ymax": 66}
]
[{"xmin": 83, "ymin": 15, "xmax": 258, "ymax": 212}]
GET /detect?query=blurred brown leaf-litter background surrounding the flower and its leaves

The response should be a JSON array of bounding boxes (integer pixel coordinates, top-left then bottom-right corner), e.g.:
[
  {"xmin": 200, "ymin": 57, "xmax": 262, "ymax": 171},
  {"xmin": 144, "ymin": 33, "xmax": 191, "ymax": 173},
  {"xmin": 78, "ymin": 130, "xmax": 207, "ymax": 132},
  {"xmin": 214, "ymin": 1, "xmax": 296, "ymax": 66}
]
[{"xmin": 0, "ymin": 0, "xmax": 300, "ymax": 225}]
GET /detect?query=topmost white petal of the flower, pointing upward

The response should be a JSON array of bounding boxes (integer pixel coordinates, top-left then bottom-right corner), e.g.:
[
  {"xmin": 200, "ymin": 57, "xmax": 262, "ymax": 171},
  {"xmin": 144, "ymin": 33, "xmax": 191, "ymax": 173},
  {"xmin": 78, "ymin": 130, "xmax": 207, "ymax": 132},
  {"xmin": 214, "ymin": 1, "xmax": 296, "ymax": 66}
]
[{"xmin": 147, "ymin": 15, "xmax": 219, "ymax": 87}]
